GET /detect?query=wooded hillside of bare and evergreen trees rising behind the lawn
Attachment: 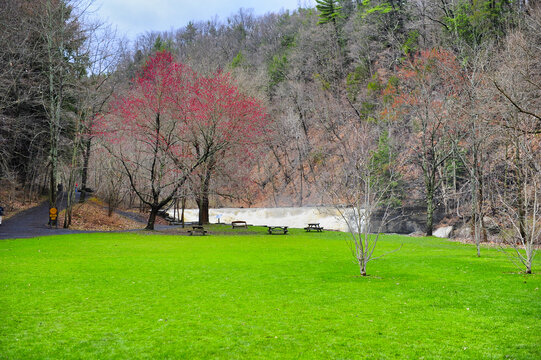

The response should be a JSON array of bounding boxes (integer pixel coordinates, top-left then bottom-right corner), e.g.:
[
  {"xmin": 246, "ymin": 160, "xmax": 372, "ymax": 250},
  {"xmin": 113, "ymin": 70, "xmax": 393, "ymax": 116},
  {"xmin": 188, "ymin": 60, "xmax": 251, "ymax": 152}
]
[{"xmin": 0, "ymin": 0, "xmax": 541, "ymax": 245}]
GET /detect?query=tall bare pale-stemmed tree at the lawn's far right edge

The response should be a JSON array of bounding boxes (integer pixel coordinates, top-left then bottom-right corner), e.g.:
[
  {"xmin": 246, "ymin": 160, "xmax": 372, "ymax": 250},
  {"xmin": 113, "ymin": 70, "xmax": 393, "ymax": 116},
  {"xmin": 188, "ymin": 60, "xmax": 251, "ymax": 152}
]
[{"xmin": 492, "ymin": 6, "xmax": 541, "ymax": 273}]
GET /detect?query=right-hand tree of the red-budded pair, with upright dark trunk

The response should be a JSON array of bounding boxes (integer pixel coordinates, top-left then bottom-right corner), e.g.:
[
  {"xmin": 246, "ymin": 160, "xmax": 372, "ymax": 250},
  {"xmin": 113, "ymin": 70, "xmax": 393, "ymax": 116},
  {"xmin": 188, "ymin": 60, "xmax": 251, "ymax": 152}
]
[{"xmin": 190, "ymin": 73, "xmax": 269, "ymax": 224}]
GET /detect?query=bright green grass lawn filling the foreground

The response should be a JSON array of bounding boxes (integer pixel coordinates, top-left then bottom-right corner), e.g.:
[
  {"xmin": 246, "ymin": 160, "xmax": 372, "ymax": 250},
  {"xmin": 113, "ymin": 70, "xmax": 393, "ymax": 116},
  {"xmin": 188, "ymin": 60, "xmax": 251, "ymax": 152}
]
[{"xmin": 0, "ymin": 227, "xmax": 541, "ymax": 359}]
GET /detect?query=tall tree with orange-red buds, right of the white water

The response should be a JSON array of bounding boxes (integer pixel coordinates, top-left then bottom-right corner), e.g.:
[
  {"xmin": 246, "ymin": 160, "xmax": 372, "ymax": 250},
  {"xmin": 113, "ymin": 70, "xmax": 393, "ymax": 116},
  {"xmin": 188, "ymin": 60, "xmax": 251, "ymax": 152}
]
[{"xmin": 395, "ymin": 49, "xmax": 463, "ymax": 236}]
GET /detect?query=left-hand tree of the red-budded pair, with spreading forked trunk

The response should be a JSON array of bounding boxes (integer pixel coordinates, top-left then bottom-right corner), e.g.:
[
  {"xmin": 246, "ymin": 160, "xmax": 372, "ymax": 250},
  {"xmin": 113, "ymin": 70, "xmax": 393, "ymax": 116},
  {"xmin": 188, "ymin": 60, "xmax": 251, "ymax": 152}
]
[{"xmin": 96, "ymin": 52, "xmax": 208, "ymax": 230}]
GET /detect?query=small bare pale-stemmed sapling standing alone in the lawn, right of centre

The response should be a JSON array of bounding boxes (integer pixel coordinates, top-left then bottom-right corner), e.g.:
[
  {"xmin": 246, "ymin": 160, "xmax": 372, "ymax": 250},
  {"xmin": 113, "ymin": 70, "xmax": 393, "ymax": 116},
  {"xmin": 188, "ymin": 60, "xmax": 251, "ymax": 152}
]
[{"xmin": 326, "ymin": 123, "xmax": 398, "ymax": 276}]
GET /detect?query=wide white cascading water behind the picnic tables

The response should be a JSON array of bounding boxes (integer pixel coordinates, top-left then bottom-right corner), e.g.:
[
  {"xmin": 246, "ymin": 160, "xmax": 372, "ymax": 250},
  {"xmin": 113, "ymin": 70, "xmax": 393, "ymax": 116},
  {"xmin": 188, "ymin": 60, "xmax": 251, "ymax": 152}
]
[{"xmin": 168, "ymin": 206, "xmax": 354, "ymax": 231}]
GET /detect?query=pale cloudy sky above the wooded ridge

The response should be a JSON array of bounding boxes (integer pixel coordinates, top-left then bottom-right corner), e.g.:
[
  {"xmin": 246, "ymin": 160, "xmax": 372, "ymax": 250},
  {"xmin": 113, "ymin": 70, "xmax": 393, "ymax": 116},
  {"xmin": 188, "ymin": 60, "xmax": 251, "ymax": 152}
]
[{"xmin": 94, "ymin": 0, "xmax": 314, "ymax": 40}]
